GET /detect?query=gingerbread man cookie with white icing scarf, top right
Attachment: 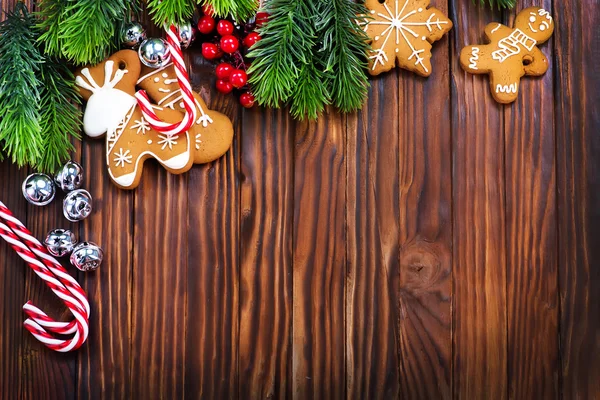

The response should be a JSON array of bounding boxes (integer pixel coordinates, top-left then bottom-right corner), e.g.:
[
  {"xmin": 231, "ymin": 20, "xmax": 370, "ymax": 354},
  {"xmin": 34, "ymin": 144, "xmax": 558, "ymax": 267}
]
[{"xmin": 460, "ymin": 7, "xmax": 554, "ymax": 104}]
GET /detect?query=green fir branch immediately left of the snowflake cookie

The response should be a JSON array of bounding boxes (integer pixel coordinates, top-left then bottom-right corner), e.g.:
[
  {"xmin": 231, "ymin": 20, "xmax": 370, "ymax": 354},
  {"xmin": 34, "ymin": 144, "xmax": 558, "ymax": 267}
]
[{"xmin": 317, "ymin": 0, "xmax": 369, "ymax": 112}]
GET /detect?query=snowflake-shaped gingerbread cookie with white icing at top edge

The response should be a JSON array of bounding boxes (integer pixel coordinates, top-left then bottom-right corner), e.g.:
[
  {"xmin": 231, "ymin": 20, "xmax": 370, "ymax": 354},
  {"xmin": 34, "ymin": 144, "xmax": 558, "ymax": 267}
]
[{"xmin": 359, "ymin": 0, "xmax": 452, "ymax": 76}]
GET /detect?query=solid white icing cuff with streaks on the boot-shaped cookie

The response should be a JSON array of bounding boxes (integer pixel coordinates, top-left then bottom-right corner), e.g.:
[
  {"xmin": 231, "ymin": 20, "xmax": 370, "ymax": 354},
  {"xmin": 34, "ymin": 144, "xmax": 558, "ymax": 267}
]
[{"xmin": 75, "ymin": 60, "xmax": 136, "ymax": 137}]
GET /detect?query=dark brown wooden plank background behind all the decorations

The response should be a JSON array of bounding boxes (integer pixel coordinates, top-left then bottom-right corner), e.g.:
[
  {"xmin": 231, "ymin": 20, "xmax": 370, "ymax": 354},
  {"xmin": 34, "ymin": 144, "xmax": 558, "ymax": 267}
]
[{"xmin": 0, "ymin": 0, "xmax": 600, "ymax": 400}]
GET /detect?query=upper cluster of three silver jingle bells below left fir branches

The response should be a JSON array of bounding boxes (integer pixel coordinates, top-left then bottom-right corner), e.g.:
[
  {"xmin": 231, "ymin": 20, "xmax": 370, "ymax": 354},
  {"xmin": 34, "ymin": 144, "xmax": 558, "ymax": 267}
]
[{"xmin": 22, "ymin": 161, "xmax": 92, "ymax": 222}]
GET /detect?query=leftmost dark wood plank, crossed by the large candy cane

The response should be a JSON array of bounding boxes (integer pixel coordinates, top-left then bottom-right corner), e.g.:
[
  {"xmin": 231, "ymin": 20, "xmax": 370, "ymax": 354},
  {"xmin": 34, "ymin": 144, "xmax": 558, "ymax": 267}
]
[{"xmin": 0, "ymin": 160, "xmax": 29, "ymax": 399}]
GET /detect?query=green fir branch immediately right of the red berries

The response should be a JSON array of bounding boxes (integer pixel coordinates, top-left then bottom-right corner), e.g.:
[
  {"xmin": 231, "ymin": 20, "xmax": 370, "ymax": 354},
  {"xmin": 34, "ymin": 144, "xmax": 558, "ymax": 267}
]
[{"xmin": 248, "ymin": 0, "xmax": 314, "ymax": 108}]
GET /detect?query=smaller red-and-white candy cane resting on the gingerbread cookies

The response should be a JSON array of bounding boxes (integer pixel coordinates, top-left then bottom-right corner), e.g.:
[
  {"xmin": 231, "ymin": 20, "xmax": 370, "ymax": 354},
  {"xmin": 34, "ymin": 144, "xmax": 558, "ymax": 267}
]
[{"xmin": 135, "ymin": 25, "xmax": 196, "ymax": 136}]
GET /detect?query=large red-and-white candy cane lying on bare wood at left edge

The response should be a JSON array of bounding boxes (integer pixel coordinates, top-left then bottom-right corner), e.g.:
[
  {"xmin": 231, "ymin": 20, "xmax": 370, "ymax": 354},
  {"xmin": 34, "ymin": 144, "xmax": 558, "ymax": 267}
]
[{"xmin": 0, "ymin": 202, "xmax": 90, "ymax": 352}]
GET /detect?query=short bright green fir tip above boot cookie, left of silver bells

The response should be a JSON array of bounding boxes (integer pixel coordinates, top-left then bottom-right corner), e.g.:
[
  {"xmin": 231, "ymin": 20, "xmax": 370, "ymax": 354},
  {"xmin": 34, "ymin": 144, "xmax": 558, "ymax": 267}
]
[{"xmin": 58, "ymin": 0, "xmax": 130, "ymax": 64}]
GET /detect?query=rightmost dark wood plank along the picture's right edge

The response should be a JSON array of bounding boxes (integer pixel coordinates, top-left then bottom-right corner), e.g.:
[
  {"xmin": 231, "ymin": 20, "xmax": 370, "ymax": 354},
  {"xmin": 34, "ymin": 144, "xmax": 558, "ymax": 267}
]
[{"xmin": 554, "ymin": 0, "xmax": 600, "ymax": 399}]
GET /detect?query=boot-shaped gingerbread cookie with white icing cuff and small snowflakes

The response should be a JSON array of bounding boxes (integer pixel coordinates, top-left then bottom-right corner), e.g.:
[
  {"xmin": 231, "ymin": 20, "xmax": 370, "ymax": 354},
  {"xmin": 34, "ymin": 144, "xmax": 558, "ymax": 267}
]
[{"xmin": 76, "ymin": 50, "xmax": 233, "ymax": 189}]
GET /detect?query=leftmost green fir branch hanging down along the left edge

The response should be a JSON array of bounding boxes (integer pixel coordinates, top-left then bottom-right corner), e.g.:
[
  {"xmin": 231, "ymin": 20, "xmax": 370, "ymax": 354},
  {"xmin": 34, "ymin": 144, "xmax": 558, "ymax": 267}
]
[{"xmin": 0, "ymin": 2, "xmax": 43, "ymax": 166}]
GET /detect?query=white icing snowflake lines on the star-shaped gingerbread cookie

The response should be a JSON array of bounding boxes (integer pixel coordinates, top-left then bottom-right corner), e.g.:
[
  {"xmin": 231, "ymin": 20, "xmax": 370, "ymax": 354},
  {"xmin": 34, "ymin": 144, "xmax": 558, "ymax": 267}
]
[{"xmin": 363, "ymin": 0, "xmax": 448, "ymax": 72}]
